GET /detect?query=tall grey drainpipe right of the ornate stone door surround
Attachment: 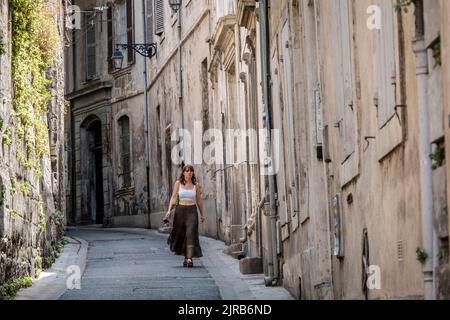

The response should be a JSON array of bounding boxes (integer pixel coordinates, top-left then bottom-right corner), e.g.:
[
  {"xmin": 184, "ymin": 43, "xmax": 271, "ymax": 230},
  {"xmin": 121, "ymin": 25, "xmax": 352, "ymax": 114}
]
[{"xmin": 259, "ymin": 0, "xmax": 279, "ymax": 286}]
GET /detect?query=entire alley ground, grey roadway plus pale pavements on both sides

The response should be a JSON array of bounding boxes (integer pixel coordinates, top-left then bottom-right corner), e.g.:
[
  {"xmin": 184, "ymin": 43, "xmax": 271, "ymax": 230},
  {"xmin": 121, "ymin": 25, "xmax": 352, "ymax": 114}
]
[{"xmin": 17, "ymin": 227, "xmax": 294, "ymax": 300}]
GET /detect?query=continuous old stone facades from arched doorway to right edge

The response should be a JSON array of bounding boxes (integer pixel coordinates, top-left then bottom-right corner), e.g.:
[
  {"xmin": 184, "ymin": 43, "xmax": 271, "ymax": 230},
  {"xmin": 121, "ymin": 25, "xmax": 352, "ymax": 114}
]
[{"xmin": 66, "ymin": 0, "xmax": 450, "ymax": 299}]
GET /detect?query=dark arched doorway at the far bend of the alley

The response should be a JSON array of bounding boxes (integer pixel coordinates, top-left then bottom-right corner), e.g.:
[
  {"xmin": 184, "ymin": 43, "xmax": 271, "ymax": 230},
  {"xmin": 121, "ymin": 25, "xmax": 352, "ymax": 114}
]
[{"xmin": 80, "ymin": 117, "xmax": 104, "ymax": 224}]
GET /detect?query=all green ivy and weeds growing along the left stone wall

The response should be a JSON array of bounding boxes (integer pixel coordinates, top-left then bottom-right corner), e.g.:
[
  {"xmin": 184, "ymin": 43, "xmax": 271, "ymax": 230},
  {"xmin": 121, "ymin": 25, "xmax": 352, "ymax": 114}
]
[{"xmin": 0, "ymin": 0, "xmax": 65, "ymax": 300}]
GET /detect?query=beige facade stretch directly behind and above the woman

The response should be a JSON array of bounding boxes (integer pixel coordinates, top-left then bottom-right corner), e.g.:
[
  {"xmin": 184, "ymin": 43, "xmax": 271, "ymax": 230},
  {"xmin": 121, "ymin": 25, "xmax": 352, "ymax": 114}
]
[{"xmin": 148, "ymin": 0, "xmax": 220, "ymax": 238}]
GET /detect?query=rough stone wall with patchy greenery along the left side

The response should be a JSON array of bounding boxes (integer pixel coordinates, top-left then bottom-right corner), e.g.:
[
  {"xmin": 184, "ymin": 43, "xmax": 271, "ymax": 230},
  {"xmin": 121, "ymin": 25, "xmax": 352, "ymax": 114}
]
[{"xmin": 0, "ymin": 0, "xmax": 66, "ymax": 284}]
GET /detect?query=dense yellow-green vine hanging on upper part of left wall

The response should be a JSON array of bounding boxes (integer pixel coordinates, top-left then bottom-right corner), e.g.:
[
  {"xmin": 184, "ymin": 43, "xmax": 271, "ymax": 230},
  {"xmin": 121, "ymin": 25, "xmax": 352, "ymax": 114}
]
[{"xmin": 6, "ymin": 0, "xmax": 59, "ymax": 177}]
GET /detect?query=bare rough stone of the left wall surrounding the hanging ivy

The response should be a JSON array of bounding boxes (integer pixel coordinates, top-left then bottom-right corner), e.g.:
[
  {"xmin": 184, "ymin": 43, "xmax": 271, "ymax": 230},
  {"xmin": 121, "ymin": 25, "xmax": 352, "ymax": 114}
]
[{"xmin": 0, "ymin": 0, "xmax": 66, "ymax": 284}]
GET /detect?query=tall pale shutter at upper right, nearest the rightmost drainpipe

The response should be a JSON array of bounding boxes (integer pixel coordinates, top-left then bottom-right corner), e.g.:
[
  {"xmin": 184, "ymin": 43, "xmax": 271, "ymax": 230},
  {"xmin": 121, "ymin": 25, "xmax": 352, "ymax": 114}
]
[{"xmin": 375, "ymin": 0, "xmax": 396, "ymax": 128}]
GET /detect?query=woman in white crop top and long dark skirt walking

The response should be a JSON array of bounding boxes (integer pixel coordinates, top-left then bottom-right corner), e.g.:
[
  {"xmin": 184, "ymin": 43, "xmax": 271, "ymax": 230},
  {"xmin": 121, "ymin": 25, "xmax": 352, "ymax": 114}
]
[{"xmin": 164, "ymin": 165, "xmax": 205, "ymax": 268}]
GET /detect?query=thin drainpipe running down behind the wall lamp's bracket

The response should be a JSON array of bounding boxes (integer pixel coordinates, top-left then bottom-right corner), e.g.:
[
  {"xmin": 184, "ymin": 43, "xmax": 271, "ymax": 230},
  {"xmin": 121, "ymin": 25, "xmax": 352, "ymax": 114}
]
[{"xmin": 142, "ymin": 0, "xmax": 152, "ymax": 229}]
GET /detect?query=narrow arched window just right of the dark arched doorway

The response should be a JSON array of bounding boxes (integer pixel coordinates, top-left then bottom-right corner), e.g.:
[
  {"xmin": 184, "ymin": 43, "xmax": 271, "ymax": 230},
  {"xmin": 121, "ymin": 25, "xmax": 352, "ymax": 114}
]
[{"xmin": 118, "ymin": 116, "xmax": 131, "ymax": 188}]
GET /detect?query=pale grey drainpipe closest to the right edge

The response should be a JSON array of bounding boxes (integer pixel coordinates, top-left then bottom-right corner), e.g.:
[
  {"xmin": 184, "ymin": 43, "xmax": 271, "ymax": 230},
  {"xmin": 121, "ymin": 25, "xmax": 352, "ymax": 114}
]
[{"xmin": 414, "ymin": 1, "xmax": 435, "ymax": 300}]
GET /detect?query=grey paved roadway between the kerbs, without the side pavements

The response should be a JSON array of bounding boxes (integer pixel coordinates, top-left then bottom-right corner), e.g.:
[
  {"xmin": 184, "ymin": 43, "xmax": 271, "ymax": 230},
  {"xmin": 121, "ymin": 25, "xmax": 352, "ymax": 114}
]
[{"xmin": 61, "ymin": 229, "xmax": 220, "ymax": 300}]
